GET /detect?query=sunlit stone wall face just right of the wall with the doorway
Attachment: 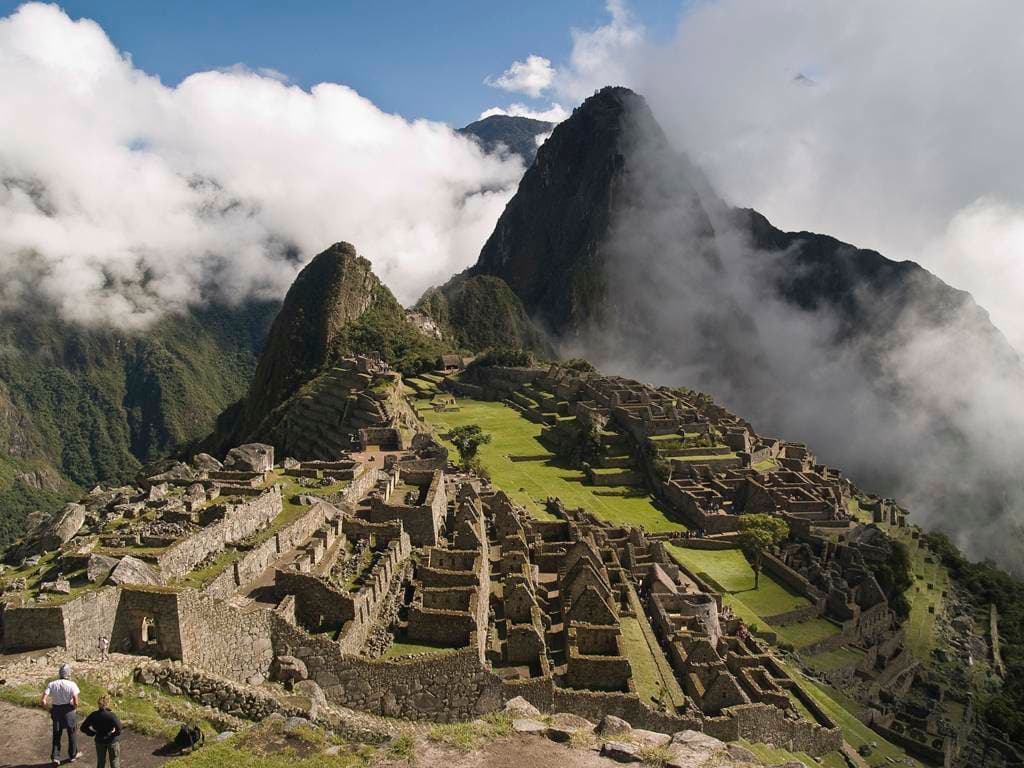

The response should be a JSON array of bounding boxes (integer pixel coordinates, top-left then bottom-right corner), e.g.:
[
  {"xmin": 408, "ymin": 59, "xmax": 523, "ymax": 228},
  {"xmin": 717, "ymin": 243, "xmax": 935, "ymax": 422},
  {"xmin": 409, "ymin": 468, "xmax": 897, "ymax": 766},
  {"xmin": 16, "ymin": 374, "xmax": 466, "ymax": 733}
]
[{"xmin": 178, "ymin": 590, "xmax": 283, "ymax": 683}]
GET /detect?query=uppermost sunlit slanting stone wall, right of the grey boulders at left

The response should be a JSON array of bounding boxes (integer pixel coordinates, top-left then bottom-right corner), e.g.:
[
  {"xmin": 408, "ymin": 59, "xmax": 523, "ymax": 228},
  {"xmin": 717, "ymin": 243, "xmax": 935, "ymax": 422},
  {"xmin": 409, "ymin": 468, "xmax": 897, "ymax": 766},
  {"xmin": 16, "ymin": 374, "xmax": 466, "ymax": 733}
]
[{"xmin": 156, "ymin": 485, "xmax": 284, "ymax": 580}]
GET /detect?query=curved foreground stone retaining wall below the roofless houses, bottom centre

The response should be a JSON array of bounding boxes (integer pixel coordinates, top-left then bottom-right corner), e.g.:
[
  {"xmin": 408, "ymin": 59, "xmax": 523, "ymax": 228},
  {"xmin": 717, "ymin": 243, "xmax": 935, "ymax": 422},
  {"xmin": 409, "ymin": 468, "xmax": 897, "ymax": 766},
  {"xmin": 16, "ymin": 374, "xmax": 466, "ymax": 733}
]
[{"xmin": 273, "ymin": 617, "xmax": 504, "ymax": 722}]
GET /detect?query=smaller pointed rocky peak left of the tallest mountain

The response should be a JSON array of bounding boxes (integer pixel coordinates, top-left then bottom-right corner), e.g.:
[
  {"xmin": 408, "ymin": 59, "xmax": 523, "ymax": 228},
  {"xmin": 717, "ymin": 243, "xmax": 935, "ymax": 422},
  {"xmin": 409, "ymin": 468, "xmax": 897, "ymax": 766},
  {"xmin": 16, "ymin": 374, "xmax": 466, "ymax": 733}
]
[{"xmin": 212, "ymin": 243, "xmax": 449, "ymax": 444}]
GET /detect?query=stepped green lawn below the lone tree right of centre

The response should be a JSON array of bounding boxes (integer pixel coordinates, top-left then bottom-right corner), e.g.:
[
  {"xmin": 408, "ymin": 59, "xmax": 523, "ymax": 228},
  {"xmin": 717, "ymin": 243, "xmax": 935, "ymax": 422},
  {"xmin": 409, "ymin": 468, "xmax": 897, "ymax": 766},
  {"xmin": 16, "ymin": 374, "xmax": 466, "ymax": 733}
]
[{"xmin": 669, "ymin": 545, "xmax": 839, "ymax": 648}]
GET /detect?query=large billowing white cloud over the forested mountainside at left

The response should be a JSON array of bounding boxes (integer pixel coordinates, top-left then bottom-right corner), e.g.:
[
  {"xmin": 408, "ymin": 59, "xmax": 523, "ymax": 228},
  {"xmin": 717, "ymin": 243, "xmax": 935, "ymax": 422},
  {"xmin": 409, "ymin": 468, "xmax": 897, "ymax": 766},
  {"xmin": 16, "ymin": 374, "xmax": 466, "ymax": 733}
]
[{"xmin": 0, "ymin": 4, "xmax": 522, "ymax": 326}]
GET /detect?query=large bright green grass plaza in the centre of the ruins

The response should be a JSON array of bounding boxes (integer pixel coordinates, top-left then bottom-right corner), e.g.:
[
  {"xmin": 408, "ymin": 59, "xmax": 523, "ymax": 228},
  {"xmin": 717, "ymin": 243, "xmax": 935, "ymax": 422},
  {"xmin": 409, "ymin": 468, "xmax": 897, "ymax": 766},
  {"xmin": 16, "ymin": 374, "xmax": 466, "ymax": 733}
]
[{"xmin": 420, "ymin": 397, "xmax": 686, "ymax": 531}]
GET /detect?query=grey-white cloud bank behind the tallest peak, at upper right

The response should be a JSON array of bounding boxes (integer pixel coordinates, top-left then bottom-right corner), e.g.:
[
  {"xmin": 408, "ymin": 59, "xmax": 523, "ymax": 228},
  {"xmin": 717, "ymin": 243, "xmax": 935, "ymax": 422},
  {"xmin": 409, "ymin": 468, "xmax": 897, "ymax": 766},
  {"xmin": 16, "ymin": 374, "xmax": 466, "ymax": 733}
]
[{"xmin": 493, "ymin": 0, "xmax": 1024, "ymax": 351}]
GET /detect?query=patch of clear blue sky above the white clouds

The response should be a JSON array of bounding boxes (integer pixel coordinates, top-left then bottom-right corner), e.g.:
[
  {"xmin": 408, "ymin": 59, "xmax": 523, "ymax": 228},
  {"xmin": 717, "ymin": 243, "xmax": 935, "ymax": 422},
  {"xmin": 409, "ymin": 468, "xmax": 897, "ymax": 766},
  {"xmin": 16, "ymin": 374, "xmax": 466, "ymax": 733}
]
[{"xmin": 0, "ymin": 0, "xmax": 681, "ymax": 125}]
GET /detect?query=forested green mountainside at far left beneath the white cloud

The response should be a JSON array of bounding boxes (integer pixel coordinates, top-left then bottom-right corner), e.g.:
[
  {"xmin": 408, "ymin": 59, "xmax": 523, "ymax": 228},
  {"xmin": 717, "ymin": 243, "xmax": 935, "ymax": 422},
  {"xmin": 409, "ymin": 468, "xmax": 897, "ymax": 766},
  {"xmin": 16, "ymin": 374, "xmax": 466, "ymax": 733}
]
[{"xmin": 0, "ymin": 302, "xmax": 275, "ymax": 538}]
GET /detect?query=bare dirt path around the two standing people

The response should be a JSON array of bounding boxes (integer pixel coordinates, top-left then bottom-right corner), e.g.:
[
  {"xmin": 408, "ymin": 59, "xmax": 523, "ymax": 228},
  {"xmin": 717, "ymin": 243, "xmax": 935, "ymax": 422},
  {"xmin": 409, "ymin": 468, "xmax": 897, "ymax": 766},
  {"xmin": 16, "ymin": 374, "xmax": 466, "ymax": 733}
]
[{"xmin": 0, "ymin": 701, "xmax": 170, "ymax": 768}]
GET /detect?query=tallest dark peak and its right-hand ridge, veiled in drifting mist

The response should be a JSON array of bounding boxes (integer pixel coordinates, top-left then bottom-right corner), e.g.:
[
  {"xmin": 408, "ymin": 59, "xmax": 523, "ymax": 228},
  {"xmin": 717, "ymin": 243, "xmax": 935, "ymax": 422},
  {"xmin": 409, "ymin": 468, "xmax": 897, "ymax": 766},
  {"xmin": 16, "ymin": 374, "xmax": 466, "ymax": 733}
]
[{"xmin": 452, "ymin": 88, "xmax": 1024, "ymax": 566}]
